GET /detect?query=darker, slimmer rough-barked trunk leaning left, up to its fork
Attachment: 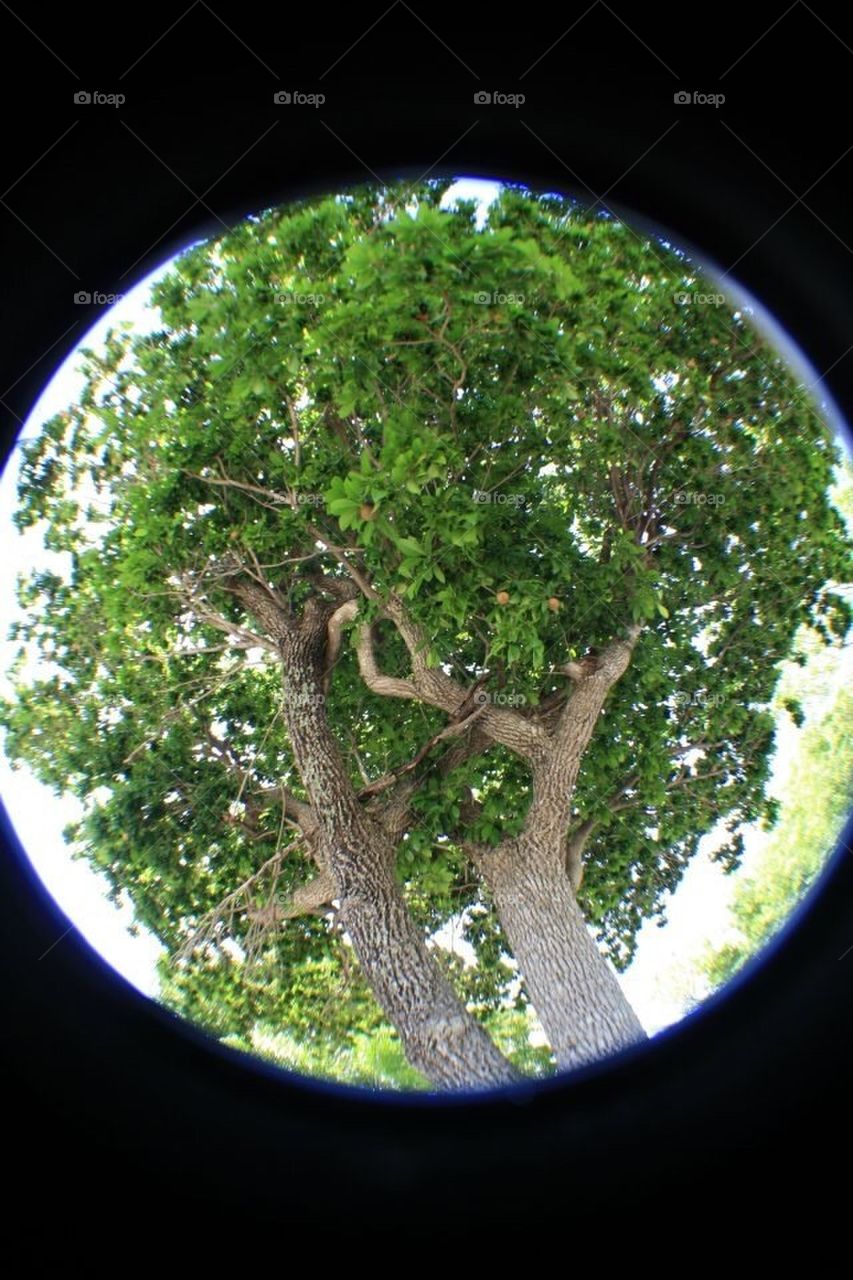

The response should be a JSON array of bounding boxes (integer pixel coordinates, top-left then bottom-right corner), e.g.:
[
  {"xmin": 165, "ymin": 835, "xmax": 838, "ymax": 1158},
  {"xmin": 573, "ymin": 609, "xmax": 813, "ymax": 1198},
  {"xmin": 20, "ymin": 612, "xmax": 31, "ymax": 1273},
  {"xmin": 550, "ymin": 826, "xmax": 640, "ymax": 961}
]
[{"xmin": 225, "ymin": 579, "xmax": 517, "ymax": 1088}]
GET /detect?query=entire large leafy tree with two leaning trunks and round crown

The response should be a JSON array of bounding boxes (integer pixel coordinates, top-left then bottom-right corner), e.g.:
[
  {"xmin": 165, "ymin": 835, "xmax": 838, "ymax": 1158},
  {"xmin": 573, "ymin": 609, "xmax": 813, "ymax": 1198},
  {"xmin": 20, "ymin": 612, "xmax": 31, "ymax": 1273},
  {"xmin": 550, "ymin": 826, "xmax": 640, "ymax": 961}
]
[{"xmin": 4, "ymin": 182, "xmax": 850, "ymax": 1087}]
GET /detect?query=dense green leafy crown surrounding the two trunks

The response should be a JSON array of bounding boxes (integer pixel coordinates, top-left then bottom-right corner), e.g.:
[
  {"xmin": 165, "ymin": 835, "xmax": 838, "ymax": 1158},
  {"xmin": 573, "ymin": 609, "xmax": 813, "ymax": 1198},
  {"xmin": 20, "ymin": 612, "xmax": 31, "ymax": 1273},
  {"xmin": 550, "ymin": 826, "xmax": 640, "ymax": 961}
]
[{"xmin": 0, "ymin": 182, "xmax": 850, "ymax": 1076}]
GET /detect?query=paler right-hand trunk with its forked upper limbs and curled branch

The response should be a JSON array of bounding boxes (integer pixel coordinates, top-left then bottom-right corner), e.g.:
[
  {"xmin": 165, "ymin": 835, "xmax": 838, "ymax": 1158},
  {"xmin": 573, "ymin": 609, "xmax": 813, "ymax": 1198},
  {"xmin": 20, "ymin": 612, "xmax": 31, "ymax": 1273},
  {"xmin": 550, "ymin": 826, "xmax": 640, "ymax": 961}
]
[{"xmin": 345, "ymin": 582, "xmax": 646, "ymax": 1068}]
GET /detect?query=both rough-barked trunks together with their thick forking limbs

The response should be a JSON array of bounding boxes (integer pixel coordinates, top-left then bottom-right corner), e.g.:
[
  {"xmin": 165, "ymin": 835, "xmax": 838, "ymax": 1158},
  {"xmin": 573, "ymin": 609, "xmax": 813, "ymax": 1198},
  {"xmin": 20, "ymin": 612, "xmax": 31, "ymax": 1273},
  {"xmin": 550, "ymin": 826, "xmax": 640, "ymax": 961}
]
[{"xmin": 219, "ymin": 557, "xmax": 644, "ymax": 1087}]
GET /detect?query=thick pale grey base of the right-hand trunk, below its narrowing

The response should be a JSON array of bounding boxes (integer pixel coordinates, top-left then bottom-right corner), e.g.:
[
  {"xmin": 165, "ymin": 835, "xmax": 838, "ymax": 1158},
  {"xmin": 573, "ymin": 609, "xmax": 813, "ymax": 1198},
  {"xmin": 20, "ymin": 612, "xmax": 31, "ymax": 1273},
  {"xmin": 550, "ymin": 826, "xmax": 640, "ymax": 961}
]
[{"xmin": 476, "ymin": 840, "xmax": 646, "ymax": 1069}]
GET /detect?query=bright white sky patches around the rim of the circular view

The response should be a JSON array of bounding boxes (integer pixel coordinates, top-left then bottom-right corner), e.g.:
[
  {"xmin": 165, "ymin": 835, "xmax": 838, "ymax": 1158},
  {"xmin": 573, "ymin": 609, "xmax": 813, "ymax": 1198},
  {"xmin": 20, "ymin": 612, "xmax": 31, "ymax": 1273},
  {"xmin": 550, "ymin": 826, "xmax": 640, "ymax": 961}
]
[{"xmin": 0, "ymin": 179, "xmax": 853, "ymax": 1032}]
